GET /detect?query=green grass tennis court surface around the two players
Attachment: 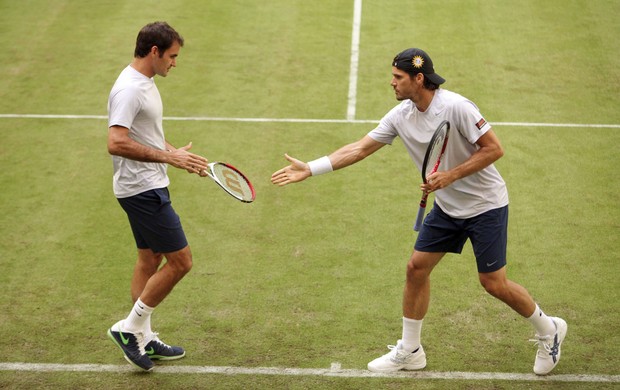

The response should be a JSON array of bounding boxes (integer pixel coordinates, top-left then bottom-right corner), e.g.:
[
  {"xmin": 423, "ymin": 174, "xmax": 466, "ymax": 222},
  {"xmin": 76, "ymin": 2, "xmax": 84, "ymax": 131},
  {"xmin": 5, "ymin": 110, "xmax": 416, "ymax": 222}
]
[{"xmin": 0, "ymin": 1, "xmax": 620, "ymax": 388}]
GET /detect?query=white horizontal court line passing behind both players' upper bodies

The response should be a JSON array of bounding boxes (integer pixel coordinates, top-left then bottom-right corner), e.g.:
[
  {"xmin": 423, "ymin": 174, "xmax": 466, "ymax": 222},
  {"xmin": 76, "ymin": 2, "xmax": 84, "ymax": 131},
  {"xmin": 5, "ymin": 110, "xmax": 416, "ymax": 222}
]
[{"xmin": 0, "ymin": 114, "xmax": 620, "ymax": 129}]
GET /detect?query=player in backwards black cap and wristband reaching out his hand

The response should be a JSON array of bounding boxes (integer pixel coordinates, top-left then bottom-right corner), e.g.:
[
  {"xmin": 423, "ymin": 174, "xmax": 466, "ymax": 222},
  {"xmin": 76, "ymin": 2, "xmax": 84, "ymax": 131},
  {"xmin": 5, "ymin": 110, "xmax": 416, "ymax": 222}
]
[{"xmin": 271, "ymin": 48, "xmax": 567, "ymax": 375}]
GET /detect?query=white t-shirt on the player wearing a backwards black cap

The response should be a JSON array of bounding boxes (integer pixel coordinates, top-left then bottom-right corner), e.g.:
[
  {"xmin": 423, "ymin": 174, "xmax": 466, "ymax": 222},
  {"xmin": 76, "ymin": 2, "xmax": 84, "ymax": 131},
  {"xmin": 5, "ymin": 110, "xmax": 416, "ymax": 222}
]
[{"xmin": 368, "ymin": 89, "xmax": 508, "ymax": 219}]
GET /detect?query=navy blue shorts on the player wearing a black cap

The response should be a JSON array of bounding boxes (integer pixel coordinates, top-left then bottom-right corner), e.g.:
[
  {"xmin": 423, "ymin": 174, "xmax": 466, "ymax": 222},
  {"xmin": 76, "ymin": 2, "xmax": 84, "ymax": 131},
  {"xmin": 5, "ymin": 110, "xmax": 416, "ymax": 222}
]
[{"xmin": 414, "ymin": 203, "xmax": 508, "ymax": 273}]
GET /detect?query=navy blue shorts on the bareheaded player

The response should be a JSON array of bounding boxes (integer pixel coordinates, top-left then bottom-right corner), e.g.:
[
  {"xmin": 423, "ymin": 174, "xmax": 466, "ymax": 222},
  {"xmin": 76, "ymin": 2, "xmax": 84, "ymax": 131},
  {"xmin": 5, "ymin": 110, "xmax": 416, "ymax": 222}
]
[{"xmin": 118, "ymin": 188, "xmax": 187, "ymax": 253}]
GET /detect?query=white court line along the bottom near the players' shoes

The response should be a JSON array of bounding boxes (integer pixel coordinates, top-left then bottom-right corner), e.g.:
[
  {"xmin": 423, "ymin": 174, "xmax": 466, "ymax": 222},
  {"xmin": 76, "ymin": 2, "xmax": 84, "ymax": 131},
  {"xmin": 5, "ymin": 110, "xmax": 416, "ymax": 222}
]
[{"xmin": 0, "ymin": 363, "xmax": 620, "ymax": 383}]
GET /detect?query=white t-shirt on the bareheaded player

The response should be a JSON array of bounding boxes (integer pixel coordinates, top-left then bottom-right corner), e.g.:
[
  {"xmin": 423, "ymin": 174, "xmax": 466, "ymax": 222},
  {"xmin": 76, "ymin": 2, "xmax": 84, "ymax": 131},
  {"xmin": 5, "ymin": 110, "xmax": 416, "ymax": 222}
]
[{"xmin": 108, "ymin": 65, "xmax": 170, "ymax": 198}]
